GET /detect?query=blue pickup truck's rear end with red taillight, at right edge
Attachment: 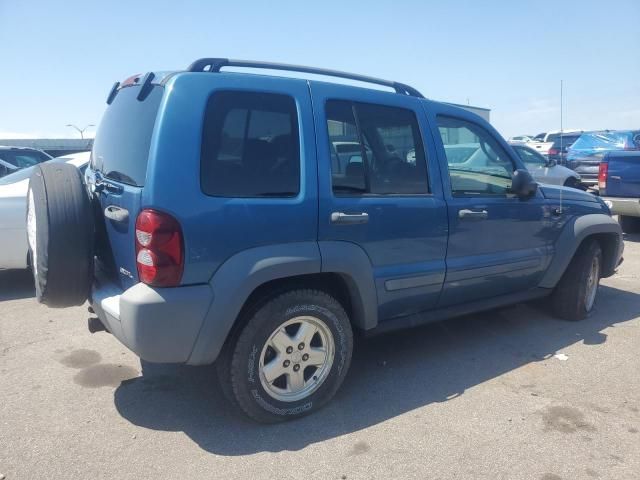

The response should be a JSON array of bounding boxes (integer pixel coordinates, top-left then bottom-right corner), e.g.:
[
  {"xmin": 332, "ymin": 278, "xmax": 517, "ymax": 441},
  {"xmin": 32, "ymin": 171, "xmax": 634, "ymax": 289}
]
[{"xmin": 598, "ymin": 151, "xmax": 640, "ymax": 233}]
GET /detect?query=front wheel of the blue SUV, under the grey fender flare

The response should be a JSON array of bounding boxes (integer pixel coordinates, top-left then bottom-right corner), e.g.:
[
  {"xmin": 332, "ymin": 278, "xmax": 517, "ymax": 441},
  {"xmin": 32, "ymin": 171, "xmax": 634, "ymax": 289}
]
[{"xmin": 551, "ymin": 240, "xmax": 602, "ymax": 321}]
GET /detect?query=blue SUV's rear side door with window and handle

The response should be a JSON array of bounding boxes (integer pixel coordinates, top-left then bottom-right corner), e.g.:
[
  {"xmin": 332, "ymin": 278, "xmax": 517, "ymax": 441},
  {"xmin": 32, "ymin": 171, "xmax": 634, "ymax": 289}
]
[{"xmin": 311, "ymin": 83, "xmax": 447, "ymax": 321}]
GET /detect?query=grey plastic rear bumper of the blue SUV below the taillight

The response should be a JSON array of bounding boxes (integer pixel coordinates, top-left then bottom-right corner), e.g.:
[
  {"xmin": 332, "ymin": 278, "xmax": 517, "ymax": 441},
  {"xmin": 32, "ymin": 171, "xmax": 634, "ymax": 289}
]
[{"xmin": 90, "ymin": 279, "xmax": 213, "ymax": 363}]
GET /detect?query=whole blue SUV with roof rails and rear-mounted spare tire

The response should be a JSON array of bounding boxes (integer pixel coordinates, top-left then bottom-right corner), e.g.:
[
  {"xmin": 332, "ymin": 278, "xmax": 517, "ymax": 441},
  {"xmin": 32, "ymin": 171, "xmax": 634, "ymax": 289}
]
[{"xmin": 27, "ymin": 58, "xmax": 623, "ymax": 422}]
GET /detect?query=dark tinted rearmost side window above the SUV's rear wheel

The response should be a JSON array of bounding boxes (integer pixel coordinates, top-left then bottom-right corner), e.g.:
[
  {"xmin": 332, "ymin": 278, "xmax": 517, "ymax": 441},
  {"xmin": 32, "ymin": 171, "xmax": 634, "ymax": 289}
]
[{"xmin": 200, "ymin": 91, "xmax": 300, "ymax": 197}]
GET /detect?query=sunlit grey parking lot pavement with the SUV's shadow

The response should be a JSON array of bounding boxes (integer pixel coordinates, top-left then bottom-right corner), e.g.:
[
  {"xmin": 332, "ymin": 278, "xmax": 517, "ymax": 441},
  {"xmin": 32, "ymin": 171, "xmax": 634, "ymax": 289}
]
[{"xmin": 0, "ymin": 236, "xmax": 640, "ymax": 480}]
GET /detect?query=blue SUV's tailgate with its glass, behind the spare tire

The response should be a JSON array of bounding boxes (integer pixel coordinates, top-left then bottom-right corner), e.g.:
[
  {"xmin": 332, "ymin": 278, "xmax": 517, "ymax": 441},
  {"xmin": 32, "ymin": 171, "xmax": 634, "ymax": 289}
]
[{"xmin": 86, "ymin": 85, "xmax": 164, "ymax": 288}]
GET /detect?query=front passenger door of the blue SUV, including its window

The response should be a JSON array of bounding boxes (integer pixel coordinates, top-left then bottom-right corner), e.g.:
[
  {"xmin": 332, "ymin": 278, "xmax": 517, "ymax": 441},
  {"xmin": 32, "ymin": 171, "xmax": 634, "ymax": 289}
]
[{"xmin": 435, "ymin": 110, "xmax": 556, "ymax": 306}]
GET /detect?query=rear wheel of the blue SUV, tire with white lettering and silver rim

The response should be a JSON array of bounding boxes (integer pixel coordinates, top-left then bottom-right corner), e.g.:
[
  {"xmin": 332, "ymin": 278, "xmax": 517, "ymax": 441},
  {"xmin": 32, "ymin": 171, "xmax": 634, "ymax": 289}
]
[{"xmin": 218, "ymin": 290, "xmax": 353, "ymax": 423}]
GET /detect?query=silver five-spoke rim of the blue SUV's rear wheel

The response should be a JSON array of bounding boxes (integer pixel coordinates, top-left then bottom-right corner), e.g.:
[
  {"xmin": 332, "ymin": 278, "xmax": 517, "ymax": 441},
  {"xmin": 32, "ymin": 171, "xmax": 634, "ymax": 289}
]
[{"xmin": 259, "ymin": 316, "xmax": 335, "ymax": 402}]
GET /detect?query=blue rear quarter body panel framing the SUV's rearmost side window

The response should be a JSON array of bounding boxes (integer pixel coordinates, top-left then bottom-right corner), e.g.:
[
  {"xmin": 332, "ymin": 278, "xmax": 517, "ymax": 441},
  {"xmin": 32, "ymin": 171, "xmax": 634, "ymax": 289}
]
[{"xmin": 141, "ymin": 73, "xmax": 318, "ymax": 284}]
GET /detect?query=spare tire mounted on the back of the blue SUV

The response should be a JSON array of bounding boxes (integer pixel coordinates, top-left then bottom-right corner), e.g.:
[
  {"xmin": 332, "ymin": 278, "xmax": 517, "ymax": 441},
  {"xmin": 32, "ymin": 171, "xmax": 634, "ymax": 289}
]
[{"xmin": 27, "ymin": 163, "xmax": 94, "ymax": 308}]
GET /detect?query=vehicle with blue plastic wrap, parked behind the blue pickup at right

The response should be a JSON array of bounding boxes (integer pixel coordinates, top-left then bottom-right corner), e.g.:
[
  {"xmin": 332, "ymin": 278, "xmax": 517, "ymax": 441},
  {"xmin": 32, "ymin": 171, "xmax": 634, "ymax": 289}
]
[{"xmin": 567, "ymin": 130, "xmax": 640, "ymax": 187}]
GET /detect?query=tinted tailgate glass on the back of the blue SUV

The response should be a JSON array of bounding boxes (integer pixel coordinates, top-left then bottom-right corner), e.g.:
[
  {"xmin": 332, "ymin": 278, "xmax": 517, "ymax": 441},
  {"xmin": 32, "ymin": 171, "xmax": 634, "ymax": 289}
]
[{"xmin": 91, "ymin": 85, "xmax": 164, "ymax": 187}]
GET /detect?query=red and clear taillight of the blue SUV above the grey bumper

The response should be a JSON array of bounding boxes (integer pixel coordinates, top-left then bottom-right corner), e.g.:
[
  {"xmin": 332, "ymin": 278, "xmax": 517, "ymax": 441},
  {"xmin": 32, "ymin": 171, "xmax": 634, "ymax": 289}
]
[{"xmin": 136, "ymin": 209, "xmax": 184, "ymax": 287}]
